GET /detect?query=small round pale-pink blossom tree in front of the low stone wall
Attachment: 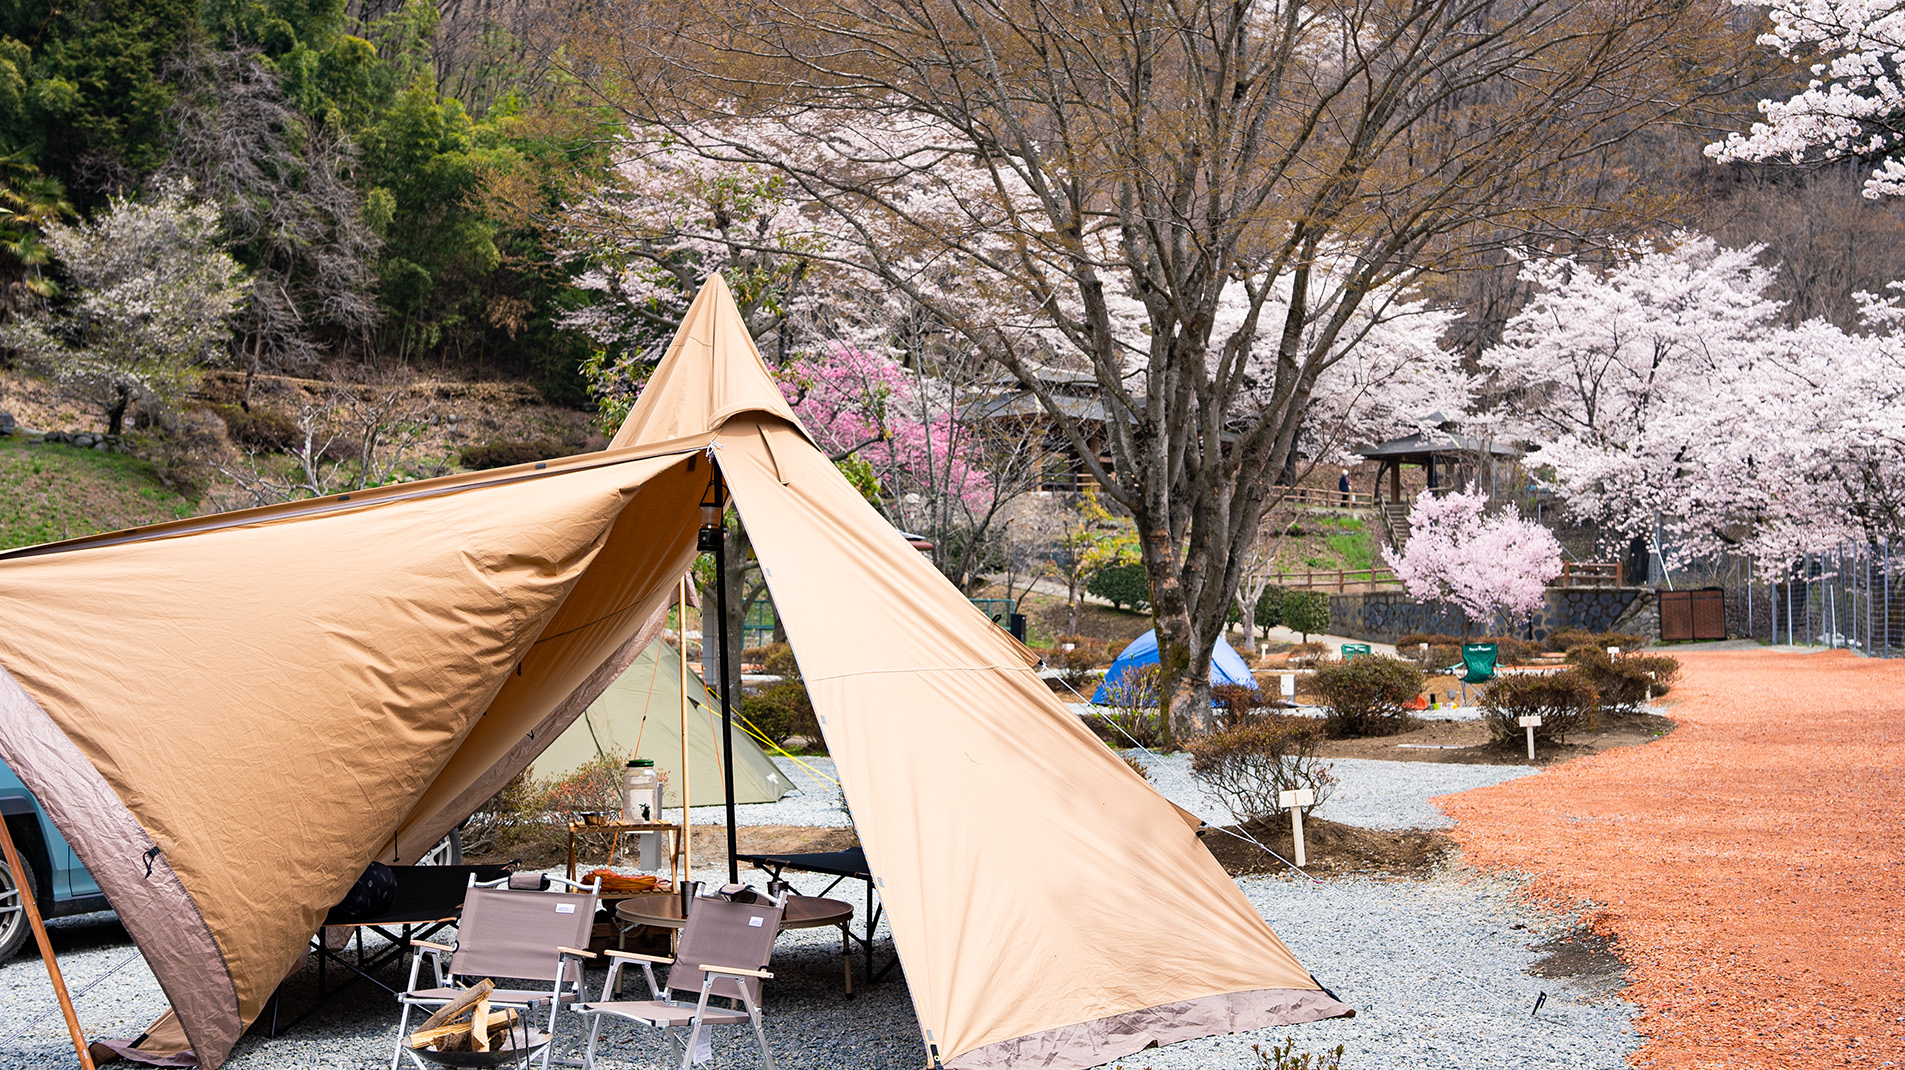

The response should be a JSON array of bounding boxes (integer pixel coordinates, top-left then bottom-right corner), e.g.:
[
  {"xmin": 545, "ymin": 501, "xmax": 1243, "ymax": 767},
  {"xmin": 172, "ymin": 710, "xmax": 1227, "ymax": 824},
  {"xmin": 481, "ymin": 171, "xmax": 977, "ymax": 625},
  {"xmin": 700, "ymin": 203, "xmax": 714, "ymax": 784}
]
[{"xmin": 1383, "ymin": 485, "xmax": 1560, "ymax": 634}]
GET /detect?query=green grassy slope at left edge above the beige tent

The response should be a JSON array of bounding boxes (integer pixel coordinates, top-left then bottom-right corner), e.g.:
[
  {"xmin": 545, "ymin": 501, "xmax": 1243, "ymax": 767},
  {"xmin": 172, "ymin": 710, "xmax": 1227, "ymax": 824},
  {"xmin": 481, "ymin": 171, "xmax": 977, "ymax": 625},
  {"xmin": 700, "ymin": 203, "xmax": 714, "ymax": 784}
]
[{"xmin": 0, "ymin": 436, "xmax": 198, "ymax": 550}]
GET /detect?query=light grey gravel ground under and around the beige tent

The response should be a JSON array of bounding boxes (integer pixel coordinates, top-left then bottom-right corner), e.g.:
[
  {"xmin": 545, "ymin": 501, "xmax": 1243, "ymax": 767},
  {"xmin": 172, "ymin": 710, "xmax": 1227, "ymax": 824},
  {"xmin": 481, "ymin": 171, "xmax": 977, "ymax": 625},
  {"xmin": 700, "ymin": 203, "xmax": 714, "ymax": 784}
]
[{"xmin": 0, "ymin": 742, "xmax": 1634, "ymax": 1070}]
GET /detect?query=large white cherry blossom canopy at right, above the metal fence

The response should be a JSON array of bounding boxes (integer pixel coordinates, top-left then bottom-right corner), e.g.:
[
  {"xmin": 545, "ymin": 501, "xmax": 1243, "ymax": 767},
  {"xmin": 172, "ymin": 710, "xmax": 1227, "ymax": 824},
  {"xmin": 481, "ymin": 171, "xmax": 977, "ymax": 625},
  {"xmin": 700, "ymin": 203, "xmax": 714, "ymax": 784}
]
[{"xmin": 1482, "ymin": 234, "xmax": 1905, "ymax": 565}]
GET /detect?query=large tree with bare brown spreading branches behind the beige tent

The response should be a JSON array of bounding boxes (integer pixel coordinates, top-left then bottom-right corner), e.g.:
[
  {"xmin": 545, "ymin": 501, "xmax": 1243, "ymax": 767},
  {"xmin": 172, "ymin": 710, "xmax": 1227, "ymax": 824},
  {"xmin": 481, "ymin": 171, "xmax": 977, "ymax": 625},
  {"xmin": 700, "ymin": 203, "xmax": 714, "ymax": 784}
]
[{"xmin": 566, "ymin": 0, "xmax": 1718, "ymax": 742}]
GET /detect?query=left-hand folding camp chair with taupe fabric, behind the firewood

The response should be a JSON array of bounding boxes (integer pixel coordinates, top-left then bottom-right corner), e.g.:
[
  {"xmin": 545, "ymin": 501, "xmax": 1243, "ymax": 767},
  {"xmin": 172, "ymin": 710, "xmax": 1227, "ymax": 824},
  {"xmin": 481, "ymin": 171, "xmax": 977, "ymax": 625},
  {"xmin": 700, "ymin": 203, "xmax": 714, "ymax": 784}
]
[{"xmin": 391, "ymin": 874, "xmax": 600, "ymax": 1070}]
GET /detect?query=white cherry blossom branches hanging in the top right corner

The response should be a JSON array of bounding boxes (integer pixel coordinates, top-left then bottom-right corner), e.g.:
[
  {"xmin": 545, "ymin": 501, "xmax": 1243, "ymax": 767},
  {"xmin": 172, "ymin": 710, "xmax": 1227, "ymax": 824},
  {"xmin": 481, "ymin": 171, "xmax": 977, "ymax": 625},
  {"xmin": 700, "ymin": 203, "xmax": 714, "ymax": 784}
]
[{"xmin": 1707, "ymin": 0, "xmax": 1905, "ymax": 198}]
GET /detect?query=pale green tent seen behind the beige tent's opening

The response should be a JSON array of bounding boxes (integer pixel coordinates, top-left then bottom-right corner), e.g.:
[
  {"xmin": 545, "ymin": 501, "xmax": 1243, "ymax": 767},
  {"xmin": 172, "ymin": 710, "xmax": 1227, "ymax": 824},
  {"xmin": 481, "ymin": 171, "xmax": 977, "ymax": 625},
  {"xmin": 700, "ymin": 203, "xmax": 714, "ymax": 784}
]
[{"xmin": 530, "ymin": 640, "xmax": 794, "ymax": 807}]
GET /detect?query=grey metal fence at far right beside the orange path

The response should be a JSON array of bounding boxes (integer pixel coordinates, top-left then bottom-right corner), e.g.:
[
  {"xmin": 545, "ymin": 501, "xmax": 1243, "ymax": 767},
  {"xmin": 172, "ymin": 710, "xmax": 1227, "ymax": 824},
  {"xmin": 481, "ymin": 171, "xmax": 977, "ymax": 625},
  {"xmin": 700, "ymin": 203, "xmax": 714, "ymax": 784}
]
[{"xmin": 1713, "ymin": 539, "xmax": 1905, "ymax": 657}]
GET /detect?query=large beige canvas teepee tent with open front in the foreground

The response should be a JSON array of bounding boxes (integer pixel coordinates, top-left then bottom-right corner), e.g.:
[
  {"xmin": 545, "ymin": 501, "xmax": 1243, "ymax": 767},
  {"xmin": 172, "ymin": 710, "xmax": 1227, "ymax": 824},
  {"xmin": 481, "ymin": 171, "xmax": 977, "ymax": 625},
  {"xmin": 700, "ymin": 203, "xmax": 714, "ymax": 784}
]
[{"xmin": 0, "ymin": 278, "xmax": 1349, "ymax": 1068}]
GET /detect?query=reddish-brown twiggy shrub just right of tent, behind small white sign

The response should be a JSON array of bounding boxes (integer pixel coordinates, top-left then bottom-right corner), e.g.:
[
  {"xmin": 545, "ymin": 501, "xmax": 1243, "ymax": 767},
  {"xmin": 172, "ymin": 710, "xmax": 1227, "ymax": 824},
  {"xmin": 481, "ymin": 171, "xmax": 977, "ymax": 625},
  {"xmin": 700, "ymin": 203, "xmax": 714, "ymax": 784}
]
[{"xmin": 1185, "ymin": 714, "xmax": 1335, "ymax": 824}]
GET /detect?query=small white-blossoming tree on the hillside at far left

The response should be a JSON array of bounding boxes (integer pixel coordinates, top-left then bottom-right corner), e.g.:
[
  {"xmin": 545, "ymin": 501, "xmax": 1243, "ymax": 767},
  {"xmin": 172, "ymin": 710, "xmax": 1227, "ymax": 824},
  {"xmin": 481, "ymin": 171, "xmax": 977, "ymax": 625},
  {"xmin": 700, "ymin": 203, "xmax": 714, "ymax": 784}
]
[{"xmin": 0, "ymin": 187, "xmax": 246, "ymax": 434}]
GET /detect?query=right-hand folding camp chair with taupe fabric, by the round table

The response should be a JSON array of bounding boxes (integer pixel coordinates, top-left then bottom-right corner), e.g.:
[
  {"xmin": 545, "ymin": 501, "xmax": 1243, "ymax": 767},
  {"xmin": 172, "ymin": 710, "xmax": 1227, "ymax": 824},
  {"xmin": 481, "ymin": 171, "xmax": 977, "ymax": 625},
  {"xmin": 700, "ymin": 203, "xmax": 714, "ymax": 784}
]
[{"xmin": 575, "ymin": 885, "xmax": 785, "ymax": 1070}]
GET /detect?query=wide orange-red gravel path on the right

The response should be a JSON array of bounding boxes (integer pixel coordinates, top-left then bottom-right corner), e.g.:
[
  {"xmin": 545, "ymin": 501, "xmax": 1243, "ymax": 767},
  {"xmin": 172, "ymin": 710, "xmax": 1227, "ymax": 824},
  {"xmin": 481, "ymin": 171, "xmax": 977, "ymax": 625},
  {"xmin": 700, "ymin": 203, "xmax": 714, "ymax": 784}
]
[{"xmin": 1440, "ymin": 653, "xmax": 1905, "ymax": 1070}]
